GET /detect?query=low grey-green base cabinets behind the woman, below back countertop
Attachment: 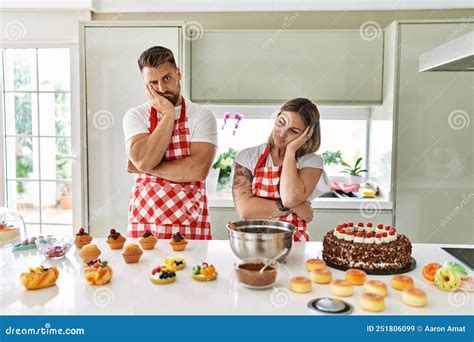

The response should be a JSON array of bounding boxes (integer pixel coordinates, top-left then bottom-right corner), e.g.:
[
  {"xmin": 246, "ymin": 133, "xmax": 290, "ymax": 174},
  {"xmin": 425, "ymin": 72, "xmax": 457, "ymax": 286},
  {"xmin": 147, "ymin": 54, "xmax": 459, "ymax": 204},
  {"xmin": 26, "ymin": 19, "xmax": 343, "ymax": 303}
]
[{"xmin": 210, "ymin": 208, "xmax": 392, "ymax": 241}]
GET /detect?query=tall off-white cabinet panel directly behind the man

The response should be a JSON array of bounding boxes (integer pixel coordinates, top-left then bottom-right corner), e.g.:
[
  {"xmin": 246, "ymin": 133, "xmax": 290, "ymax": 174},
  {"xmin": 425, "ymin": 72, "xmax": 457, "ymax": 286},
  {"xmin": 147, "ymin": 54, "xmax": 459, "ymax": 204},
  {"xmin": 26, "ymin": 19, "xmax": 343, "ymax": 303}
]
[{"xmin": 81, "ymin": 22, "xmax": 184, "ymax": 237}]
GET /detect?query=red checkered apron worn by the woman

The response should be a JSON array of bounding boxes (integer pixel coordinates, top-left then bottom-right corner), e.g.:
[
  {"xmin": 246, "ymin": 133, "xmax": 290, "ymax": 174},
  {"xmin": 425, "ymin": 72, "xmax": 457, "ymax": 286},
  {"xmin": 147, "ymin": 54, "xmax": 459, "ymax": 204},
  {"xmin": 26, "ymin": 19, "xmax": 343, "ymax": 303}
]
[{"xmin": 252, "ymin": 145, "xmax": 309, "ymax": 241}]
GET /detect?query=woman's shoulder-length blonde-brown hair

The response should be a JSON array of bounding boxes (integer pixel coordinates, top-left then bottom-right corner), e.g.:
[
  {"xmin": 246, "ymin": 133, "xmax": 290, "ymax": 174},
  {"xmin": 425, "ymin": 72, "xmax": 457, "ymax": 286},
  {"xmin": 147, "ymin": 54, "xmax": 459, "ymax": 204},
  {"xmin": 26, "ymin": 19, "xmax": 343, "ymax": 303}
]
[{"xmin": 268, "ymin": 97, "xmax": 321, "ymax": 158}]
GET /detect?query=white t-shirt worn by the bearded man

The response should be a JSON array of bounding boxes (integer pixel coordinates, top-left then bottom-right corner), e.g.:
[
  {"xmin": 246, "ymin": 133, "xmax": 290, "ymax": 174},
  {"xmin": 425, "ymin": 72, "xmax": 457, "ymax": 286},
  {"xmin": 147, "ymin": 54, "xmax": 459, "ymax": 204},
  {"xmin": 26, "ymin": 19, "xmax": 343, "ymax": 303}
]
[{"xmin": 123, "ymin": 100, "xmax": 218, "ymax": 149}]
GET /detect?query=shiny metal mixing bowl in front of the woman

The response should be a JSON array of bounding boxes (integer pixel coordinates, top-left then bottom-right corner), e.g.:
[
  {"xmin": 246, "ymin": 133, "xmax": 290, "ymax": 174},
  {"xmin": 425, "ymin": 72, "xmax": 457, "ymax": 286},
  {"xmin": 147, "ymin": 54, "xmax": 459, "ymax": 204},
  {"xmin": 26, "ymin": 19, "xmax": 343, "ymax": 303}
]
[{"xmin": 227, "ymin": 220, "xmax": 295, "ymax": 261}]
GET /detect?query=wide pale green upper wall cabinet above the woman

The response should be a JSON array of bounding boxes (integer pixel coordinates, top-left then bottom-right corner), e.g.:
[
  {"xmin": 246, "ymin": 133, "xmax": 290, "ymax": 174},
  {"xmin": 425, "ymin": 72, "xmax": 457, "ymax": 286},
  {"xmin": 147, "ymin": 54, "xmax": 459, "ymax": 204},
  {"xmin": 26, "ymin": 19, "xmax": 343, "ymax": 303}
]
[{"xmin": 191, "ymin": 30, "xmax": 383, "ymax": 104}]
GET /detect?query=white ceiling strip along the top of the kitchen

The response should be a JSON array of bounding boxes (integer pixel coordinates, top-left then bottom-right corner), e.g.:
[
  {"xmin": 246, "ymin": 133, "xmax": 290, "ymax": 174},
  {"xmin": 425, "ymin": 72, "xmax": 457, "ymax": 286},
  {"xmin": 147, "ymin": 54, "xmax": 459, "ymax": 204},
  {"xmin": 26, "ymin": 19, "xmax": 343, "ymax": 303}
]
[{"xmin": 0, "ymin": 0, "xmax": 474, "ymax": 13}]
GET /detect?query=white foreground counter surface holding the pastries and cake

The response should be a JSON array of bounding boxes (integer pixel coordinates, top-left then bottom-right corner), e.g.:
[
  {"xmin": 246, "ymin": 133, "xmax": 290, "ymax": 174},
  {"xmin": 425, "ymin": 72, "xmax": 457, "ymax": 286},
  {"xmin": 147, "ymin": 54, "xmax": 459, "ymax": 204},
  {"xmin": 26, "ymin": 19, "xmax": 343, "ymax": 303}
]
[{"xmin": 0, "ymin": 239, "xmax": 474, "ymax": 315}]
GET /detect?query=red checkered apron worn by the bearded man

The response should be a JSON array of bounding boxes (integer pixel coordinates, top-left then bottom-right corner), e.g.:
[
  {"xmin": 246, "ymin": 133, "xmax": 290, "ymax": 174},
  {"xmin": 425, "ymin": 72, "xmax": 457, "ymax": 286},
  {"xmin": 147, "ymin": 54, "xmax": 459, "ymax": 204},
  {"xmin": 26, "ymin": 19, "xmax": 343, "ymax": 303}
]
[{"xmin": 128, "ymin": 98, "xmax": 212, "ymax": 240}]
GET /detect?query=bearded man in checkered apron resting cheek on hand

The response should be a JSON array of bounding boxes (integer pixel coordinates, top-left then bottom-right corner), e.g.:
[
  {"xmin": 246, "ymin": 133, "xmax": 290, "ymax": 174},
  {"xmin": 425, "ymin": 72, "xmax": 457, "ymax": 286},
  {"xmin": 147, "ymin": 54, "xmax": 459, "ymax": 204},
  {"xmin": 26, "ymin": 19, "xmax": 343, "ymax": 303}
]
[{"xmin": 123, "ymin": 46, "xmax": 217, "ymax": 239}]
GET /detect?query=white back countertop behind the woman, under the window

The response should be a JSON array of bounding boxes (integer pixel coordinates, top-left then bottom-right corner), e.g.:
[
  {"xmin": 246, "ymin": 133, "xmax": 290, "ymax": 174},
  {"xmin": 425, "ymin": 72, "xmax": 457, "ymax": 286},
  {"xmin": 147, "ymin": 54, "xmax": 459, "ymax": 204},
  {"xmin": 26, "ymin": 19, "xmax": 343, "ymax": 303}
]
[{"xmin": 208, "ymin": 191, "xmax": 393, "ymax": 210}]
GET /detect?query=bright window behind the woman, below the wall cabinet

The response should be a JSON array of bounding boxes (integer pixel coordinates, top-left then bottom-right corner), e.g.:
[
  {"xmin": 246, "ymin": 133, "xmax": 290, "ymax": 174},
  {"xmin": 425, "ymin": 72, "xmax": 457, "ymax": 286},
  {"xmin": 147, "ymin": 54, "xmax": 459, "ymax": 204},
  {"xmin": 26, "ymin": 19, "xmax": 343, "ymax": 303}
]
[{"xmin": 218, "ymin": 118, "xmax": 367, "ymax": 176}]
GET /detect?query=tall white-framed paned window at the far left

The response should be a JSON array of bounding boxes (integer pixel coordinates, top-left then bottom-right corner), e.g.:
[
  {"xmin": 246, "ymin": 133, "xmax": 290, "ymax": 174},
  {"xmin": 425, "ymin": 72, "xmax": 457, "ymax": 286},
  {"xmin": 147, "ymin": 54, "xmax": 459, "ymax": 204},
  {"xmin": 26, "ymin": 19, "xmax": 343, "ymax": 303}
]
[{"xmin": 1, "ymin": 48, "xmax": 72, "ymax": 236}]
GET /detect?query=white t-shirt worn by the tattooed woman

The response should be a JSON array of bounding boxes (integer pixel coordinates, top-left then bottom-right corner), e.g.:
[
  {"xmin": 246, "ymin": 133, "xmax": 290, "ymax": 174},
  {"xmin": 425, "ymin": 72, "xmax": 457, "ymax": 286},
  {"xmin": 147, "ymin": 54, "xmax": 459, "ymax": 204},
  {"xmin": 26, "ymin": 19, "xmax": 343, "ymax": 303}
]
[{"xmin": 235, "ymin": 143, "xmax": 331, "ymax": 201}]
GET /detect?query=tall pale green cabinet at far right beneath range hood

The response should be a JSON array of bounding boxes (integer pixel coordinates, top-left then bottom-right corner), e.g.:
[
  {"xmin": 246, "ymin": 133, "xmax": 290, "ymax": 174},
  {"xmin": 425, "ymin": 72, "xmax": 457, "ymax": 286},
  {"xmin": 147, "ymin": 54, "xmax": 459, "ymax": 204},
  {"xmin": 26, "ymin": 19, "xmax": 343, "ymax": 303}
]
[{"xmin": 393, "ymin": 21, "xmax": 474, "ymax": 244}]
